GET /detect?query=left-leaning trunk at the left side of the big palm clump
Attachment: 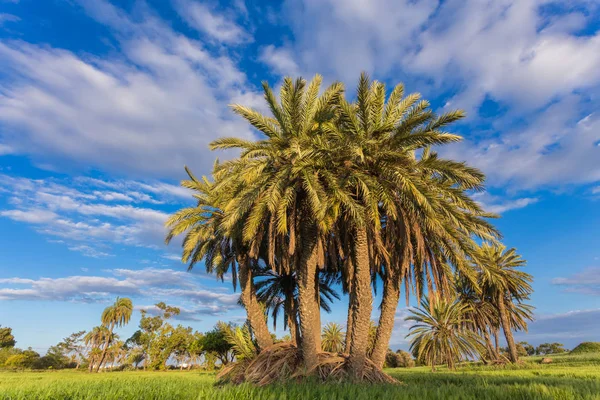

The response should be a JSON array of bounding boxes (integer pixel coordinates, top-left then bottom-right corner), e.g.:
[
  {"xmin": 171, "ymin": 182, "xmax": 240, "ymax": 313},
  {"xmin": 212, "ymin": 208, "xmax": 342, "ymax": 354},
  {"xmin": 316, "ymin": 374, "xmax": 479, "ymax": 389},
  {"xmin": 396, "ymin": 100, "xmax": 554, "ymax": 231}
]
[{"xmin": 238, "ymin": 256, "xmax": 273, "ymax": 350}]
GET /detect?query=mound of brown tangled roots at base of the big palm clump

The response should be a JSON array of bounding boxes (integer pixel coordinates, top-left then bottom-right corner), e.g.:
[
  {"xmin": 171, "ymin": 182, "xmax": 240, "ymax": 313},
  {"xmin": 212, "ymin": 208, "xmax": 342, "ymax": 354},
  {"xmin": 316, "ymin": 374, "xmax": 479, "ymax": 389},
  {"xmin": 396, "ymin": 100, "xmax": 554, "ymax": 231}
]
[{"xmin": 217, "ymin": 342, "xmax": 399, "ymax": 386}]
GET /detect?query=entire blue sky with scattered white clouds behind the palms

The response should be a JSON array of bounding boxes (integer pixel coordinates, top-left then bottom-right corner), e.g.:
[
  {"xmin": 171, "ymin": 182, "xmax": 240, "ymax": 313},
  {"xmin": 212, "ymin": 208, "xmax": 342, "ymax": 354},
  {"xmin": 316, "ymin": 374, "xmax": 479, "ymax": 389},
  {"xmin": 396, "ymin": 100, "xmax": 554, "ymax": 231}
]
[{"xmin": 0, "ymin": 0, "xmax": 600, "ymax": 351}]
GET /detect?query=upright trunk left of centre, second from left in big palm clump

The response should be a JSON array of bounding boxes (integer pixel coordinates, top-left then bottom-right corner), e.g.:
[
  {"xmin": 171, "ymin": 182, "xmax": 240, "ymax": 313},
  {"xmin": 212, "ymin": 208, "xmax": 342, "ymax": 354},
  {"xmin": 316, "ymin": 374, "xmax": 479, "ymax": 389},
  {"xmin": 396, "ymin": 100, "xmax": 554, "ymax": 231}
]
[{"xmin": 297, "ymin": 219, "xmax": 321, "ymax": 372}]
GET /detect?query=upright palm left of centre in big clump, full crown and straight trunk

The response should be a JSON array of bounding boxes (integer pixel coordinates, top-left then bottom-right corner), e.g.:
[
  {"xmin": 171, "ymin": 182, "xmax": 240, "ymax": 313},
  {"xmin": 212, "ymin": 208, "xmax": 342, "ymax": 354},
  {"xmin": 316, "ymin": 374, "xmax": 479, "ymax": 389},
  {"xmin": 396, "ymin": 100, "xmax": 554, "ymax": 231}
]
[{"xmin": 211, "ymin": 76, "xmax": 343, "ymax": 371}]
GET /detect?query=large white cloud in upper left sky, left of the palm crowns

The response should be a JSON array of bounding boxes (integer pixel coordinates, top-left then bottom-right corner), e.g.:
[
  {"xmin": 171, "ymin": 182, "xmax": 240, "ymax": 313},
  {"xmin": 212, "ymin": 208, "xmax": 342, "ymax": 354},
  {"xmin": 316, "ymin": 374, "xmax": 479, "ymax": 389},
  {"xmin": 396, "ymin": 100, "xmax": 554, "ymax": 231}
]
[{"xmin": 0, "ymin": 1, "xmax": 254, "ymax": 177}]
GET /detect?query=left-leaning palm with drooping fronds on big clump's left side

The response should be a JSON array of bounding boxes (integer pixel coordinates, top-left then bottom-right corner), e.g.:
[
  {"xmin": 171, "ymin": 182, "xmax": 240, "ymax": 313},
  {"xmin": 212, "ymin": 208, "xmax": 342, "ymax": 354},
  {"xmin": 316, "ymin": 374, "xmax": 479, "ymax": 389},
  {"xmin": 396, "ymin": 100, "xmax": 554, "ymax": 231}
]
[{"xmin": 166, "ymin": 172, "xmax": 273, "ymax": 349}]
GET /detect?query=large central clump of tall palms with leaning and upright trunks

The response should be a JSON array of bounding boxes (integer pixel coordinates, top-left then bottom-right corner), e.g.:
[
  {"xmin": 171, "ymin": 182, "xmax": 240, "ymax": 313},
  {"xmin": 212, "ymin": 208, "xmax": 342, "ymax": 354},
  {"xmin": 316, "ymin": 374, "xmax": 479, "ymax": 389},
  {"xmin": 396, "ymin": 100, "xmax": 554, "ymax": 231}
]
[{"xmin": 166, "ymin": 74, "xmax": 532, "ymax": 380}]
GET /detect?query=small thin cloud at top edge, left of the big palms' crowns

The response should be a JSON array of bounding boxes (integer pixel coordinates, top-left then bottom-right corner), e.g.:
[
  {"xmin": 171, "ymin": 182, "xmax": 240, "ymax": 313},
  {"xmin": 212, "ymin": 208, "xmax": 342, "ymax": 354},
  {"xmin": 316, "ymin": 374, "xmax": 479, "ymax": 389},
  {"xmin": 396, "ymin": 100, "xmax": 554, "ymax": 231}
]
[{"xmin": 175, "ymin": 0, "xmax": 252, "ymax": 44}]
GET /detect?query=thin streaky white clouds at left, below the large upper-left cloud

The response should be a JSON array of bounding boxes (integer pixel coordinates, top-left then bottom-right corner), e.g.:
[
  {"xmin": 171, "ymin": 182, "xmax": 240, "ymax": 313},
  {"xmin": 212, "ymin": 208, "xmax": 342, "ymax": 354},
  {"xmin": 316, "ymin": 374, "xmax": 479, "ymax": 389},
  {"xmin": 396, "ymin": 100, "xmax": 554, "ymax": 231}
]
[{"xmin": 0, "ymin": 174, "xmax": 193, "ymax": 257}]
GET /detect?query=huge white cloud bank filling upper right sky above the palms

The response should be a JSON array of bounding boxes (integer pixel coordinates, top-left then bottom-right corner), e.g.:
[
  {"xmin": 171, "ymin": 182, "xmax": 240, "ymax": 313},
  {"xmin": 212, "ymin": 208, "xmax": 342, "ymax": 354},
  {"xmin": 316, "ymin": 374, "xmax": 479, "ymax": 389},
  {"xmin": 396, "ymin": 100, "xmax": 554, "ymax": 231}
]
[{"xmin": 270, "ymin": 0, "xmax": 600, "ymax": 192}]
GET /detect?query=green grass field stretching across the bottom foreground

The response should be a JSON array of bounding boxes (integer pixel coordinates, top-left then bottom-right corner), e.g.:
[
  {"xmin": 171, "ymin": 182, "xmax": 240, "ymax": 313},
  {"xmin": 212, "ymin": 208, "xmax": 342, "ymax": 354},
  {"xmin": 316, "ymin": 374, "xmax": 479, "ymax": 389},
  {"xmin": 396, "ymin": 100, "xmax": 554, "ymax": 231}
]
[{"xmin": 0, "ymin": 353, "xmax": 600, "ymax": 400}]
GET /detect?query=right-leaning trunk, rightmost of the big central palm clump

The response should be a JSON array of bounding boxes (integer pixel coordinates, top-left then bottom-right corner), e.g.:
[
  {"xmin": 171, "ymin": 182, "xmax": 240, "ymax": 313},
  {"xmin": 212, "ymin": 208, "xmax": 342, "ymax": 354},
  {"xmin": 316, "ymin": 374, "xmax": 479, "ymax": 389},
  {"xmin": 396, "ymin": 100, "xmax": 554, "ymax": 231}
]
[{"xmin": 371, "ymin": 273, "xmax": 400, "ymax": 368}]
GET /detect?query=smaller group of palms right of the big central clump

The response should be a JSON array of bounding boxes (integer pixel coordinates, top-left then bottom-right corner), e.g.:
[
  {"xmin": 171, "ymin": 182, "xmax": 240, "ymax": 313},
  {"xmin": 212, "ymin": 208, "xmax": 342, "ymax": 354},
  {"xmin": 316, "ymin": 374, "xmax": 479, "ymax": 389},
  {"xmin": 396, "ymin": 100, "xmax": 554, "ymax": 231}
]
[{"xmin": 406, "ymin": 243, "xmax": 533, "ymax": 370}]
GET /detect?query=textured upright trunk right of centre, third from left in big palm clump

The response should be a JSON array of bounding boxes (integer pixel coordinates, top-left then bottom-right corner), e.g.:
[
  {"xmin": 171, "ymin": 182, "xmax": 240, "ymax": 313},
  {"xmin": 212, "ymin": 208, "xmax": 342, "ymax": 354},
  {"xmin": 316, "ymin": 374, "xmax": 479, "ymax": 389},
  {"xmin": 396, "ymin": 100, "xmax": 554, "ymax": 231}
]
[{"xmin": 349, "ymin": 228, "xmax": 373, "ymax": 380}]
